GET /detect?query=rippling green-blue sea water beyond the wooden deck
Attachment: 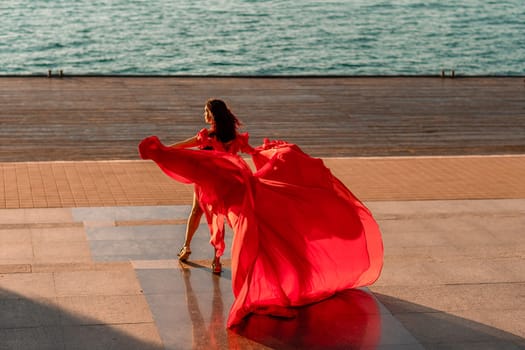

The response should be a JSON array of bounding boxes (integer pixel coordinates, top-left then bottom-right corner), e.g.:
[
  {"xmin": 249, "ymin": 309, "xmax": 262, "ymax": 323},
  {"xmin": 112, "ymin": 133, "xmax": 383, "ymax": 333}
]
[{"xmin": 0, "ymin": 0, "xmax": 525, "ymax": 75}]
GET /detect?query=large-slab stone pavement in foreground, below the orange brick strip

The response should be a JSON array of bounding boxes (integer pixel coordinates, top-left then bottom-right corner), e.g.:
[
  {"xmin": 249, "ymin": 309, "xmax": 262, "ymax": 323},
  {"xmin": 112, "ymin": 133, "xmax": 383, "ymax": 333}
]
[{"xmin": 0, "ymin": 158, "xmax": 525, "ymax": 350}]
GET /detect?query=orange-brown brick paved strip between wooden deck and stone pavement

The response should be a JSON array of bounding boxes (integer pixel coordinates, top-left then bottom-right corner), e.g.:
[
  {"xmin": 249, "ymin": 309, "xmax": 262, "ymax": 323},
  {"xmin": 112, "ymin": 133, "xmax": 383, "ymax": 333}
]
[{"xmin": 0, "ymin": 155, "xmax": 525, "ymax": 209}]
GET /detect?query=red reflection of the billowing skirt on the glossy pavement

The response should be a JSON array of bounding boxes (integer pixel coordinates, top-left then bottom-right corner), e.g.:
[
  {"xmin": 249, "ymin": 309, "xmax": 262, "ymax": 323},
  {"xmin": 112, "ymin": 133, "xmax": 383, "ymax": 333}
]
[{"xmin": 233, "ymin": 289, "xmax": 381, "ymax": 349}]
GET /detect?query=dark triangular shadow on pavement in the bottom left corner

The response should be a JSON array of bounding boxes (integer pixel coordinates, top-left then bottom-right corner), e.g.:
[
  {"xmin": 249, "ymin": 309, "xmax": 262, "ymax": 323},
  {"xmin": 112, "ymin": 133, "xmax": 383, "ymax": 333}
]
[{"xmin": 0, "ymin": 288, "xmax": 163, "ymax": 350}]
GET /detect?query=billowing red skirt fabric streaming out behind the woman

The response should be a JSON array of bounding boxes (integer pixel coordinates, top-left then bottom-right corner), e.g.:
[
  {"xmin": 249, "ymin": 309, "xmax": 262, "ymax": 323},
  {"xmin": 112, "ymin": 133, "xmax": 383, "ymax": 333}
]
[{"xmin": 139, "ymin": 136, "xmax": 383, "ymax": 327}]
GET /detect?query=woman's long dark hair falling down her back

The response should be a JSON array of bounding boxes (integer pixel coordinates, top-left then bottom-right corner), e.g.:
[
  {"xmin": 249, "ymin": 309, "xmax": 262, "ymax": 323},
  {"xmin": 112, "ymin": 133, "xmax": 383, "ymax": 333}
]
[{"xmin": 206, "ymin": 99, "xmax": 241, "ymax": 142}]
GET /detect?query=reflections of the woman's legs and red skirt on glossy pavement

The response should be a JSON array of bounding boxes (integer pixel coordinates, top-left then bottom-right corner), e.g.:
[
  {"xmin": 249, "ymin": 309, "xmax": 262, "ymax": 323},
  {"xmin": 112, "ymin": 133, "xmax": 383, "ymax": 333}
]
[{"xmin": 177, "ymin": 265, "xmax": 381, "ymax": 349}]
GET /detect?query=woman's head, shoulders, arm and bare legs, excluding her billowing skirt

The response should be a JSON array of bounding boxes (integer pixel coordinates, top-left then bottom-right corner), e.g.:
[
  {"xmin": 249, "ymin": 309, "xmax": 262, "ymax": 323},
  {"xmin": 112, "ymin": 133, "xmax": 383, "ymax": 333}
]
[{"xmin": 169, "ymin": 99, "xmax": 252, "ymax": 274}]
